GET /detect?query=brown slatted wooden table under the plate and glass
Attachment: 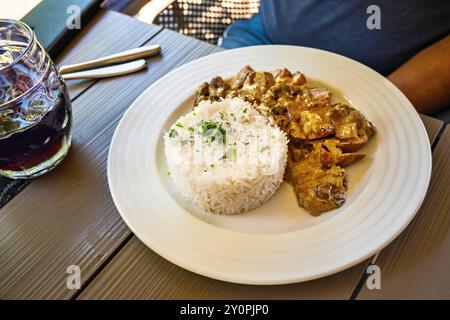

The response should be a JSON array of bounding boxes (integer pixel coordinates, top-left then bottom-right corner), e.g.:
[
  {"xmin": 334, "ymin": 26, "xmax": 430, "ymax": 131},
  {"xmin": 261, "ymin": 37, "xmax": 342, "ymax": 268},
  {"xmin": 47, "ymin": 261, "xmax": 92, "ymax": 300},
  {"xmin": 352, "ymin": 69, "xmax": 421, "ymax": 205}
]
[{"xmin": 0, "ymin": 11, "xmax": 450, "ymax": 299}]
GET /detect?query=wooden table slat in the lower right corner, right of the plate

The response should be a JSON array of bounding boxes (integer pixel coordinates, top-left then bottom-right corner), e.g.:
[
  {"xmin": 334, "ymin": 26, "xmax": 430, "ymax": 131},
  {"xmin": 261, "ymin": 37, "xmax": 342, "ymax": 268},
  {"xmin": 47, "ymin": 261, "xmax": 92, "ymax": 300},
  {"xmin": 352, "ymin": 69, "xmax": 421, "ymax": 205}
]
[{"xmin": 358, "ymin": 126, "xmax": 450, "ymax": 299}]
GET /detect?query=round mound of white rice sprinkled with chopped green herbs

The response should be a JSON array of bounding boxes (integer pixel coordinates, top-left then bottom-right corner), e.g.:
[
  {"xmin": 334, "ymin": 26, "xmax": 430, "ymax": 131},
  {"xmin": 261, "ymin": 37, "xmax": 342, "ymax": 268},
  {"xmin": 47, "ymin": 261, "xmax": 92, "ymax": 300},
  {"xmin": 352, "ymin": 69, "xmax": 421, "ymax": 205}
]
[{"xmin": 164, "ymin": 98, "xmax": 288, "ymax": 214}]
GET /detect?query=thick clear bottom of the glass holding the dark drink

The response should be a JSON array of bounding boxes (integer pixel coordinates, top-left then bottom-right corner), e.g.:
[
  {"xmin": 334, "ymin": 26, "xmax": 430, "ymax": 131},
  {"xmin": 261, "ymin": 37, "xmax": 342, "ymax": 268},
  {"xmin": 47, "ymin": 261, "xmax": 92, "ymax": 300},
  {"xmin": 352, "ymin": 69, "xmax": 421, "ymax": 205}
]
[{"xmin": 0, "ymin": 136, "xmax": 71, "ymax": 179}]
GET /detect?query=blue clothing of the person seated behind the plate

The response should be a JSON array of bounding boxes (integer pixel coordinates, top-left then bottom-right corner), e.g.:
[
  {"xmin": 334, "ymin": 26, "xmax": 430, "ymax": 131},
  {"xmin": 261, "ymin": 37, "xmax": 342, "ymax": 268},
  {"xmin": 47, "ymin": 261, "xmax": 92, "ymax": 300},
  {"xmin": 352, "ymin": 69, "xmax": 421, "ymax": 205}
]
[{"xmin": 222, "ymin": 0, "xmax": 450, "ymax": 75}]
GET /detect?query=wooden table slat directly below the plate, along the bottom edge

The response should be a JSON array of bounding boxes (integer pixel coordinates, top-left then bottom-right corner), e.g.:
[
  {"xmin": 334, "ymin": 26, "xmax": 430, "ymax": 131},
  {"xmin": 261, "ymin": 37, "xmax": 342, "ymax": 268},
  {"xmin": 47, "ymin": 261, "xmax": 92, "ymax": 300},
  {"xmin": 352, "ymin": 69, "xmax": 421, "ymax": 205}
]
[{"xmin": 79, "ymin": 237, "xmax": 367, "ymax": 299}]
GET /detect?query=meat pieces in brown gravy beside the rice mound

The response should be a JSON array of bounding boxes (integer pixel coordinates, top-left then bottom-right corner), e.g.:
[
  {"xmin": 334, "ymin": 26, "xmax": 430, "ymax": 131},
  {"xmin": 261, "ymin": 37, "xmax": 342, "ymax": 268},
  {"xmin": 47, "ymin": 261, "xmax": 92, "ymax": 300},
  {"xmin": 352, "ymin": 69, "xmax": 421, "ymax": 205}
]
[{"xmin": 194, "ymin": 66, "xmax": 375, "ymax": 215}]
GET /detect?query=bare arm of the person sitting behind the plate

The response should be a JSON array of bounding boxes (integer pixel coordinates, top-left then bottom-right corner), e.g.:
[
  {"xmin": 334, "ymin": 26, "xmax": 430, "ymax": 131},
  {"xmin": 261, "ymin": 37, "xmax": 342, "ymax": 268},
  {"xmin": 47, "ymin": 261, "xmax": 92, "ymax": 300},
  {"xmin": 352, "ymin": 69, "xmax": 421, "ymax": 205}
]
[{"xmin": 388, "ymin": 35, "xmax": 450, "ymax": 113}]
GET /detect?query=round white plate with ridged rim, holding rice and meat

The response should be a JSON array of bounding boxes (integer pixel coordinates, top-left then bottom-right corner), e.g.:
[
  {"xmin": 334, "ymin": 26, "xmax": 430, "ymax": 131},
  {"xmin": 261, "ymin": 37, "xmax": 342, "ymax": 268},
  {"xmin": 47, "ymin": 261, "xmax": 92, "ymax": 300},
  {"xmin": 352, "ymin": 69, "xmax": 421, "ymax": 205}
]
[{"xmin": 108, "ymin": 46, "xmax": 431, "ymax": 284}]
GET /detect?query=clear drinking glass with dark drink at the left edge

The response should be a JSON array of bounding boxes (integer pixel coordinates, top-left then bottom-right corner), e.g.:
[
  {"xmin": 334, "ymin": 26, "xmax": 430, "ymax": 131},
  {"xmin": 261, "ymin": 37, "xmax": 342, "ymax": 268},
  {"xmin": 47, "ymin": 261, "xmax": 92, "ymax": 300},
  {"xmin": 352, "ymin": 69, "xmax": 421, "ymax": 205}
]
[{"xmin": 0, "ymin": 19, "xmax": 72, "ymax": 179}]
